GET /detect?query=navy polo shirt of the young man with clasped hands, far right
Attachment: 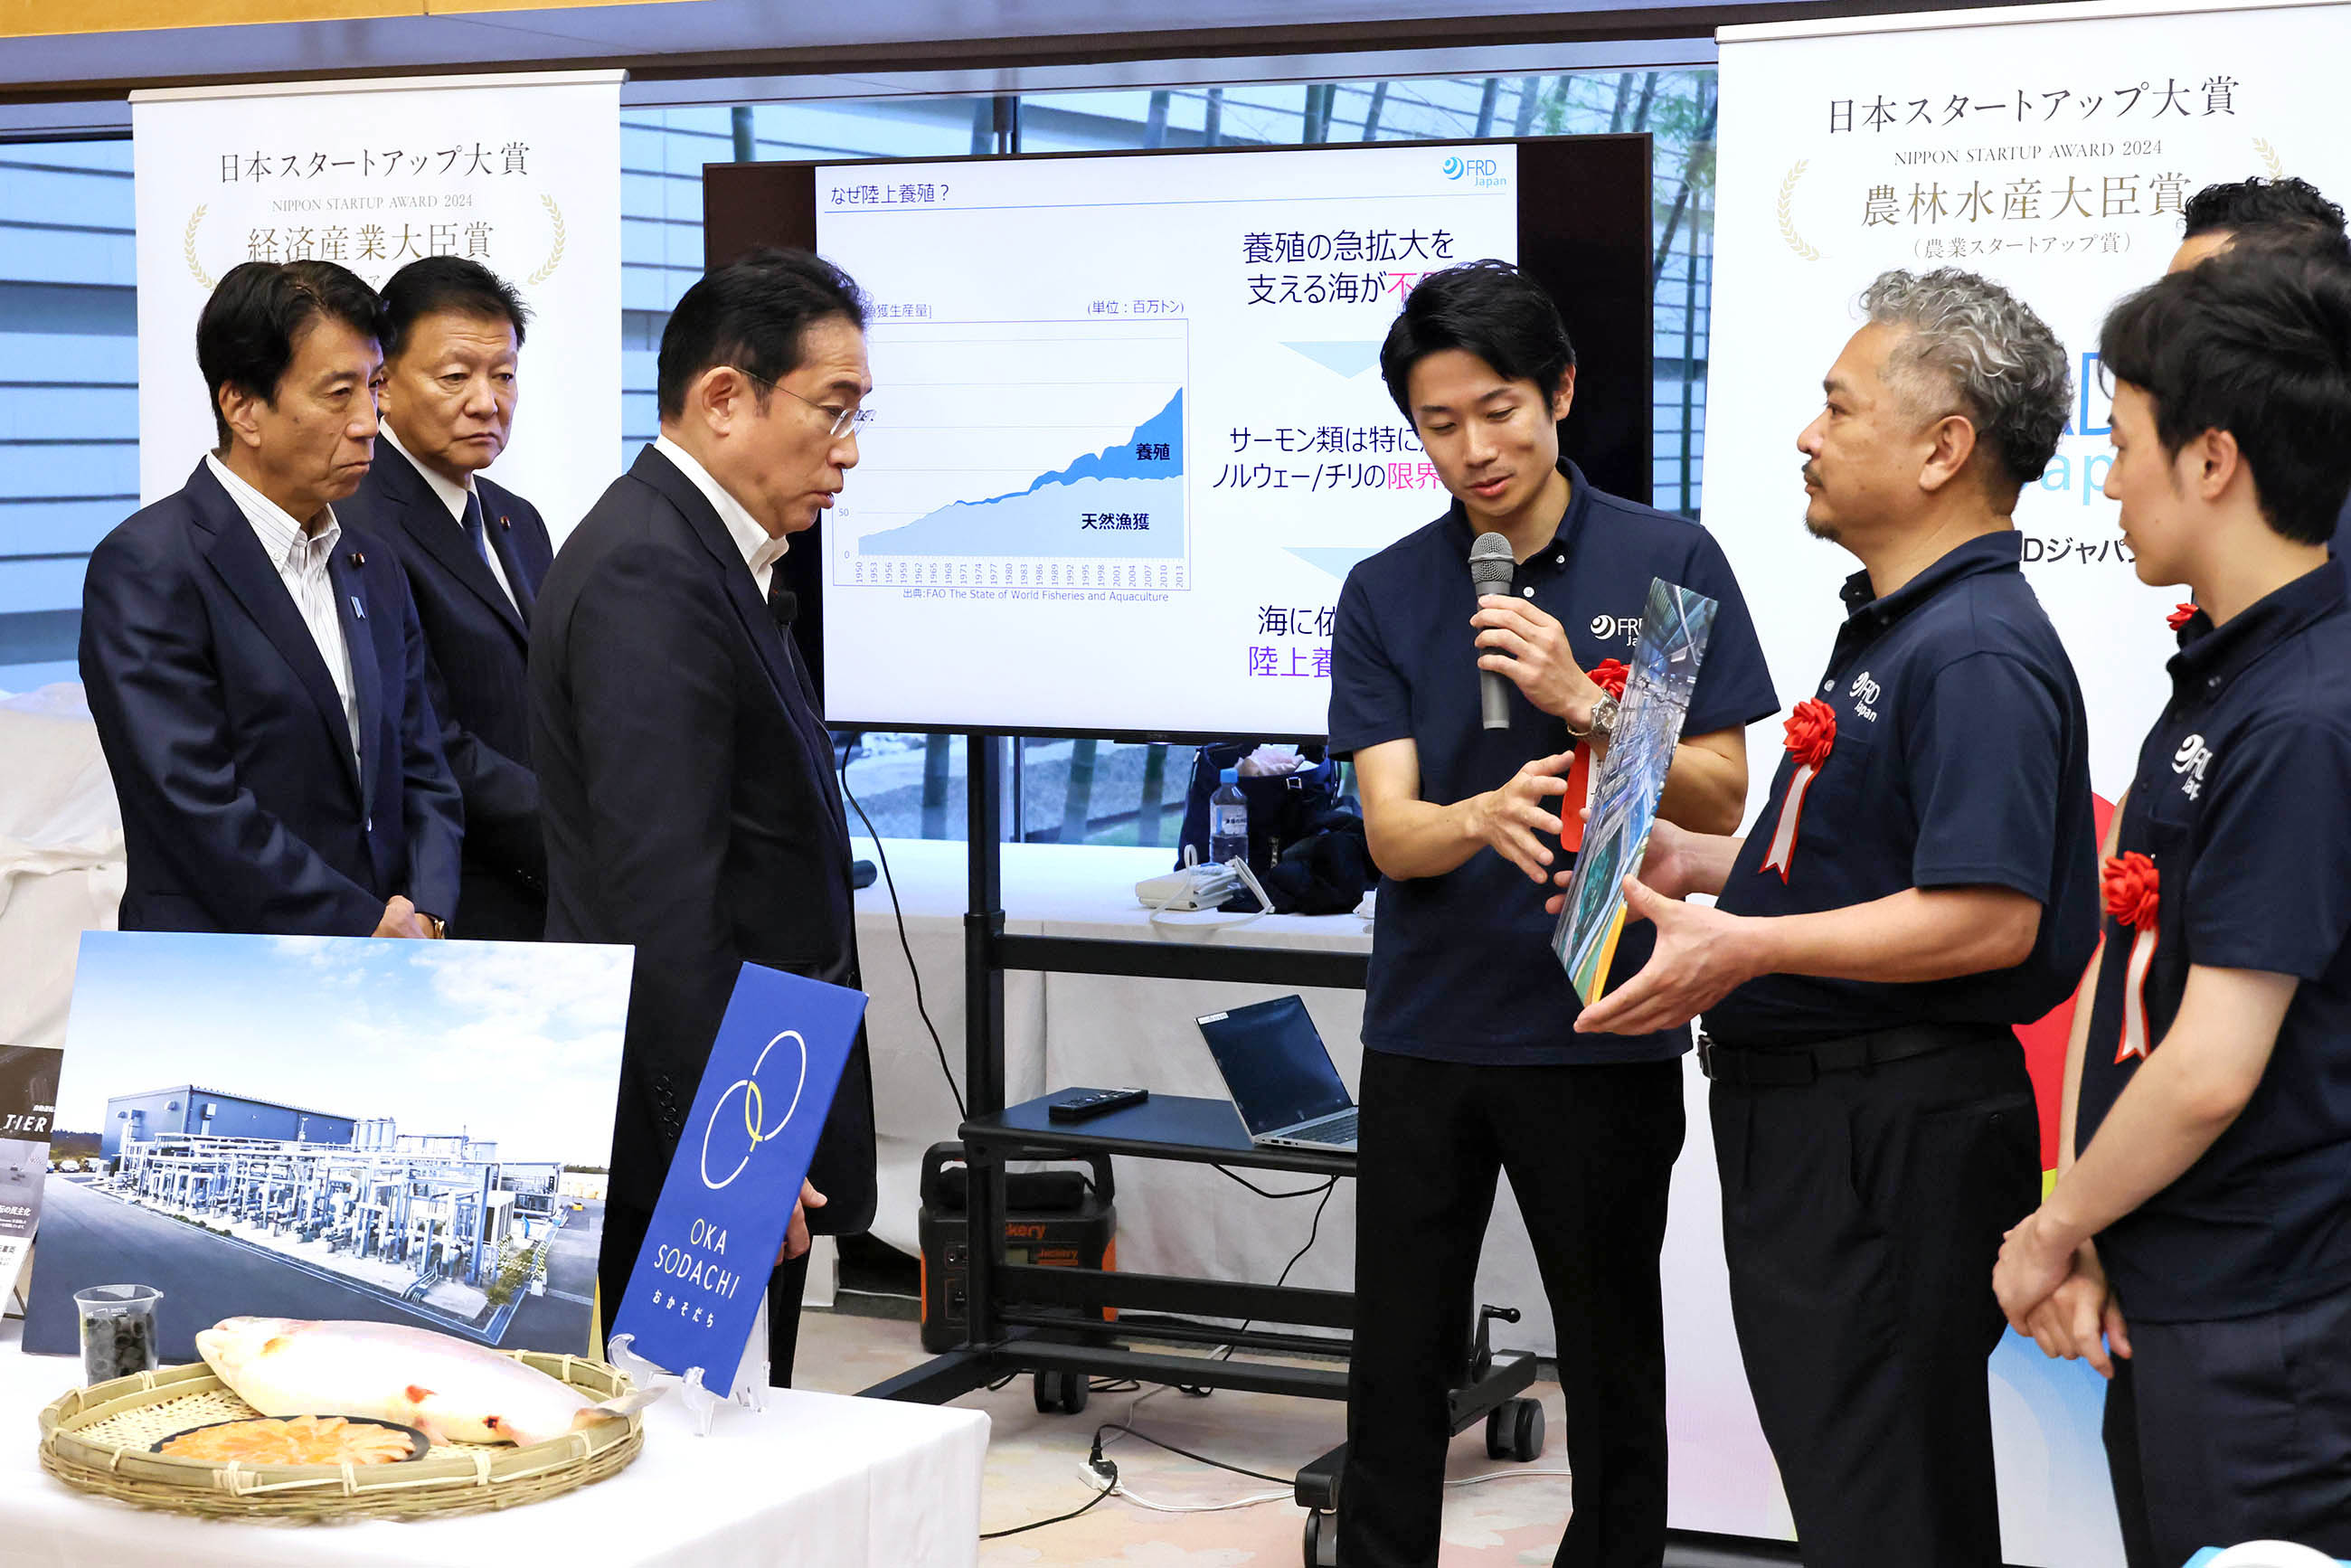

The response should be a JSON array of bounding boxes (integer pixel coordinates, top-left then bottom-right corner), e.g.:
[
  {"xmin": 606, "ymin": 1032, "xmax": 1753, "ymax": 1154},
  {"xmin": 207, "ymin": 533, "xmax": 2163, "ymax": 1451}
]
[{"xmin": 2073, "ymin": 560, "xmax": 2351, "ymax": 1324}]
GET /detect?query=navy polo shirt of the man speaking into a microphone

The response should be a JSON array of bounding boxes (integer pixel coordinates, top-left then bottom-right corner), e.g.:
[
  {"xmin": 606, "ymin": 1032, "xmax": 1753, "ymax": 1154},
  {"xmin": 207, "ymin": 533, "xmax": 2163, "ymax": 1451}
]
[{"xmin": 1331, "ymin": 463, "xmax": 1780, "ymax": 1065}]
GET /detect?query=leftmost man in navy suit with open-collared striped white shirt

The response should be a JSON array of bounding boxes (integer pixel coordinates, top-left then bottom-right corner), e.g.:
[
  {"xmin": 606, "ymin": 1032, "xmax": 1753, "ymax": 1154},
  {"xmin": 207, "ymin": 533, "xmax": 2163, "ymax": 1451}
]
[{"xmin": 82, "ymin": 261, "xmax": 463, "ymax": 936}]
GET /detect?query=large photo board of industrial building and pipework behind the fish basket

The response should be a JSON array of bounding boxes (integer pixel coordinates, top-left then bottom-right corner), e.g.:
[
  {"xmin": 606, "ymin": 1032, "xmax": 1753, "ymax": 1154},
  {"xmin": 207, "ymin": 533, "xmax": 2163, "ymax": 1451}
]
[{"xmin": 24, "ymin": 930, "xmax": 628, "ymax": 1361}]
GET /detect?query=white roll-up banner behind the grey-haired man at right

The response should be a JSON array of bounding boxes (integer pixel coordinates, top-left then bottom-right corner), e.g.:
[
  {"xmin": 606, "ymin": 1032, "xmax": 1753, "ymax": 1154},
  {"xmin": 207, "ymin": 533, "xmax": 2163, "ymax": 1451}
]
[{"xmin": 1666, "ymin": 5, "xmax": 2351, "ymax": 1568}]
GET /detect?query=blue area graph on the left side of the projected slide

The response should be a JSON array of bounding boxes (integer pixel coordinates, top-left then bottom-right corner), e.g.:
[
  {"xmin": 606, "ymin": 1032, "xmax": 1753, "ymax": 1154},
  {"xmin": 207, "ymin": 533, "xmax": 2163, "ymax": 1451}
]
[{"xmin": 827, "ymin": 317, "xmax": 1192, "ymax": 588}]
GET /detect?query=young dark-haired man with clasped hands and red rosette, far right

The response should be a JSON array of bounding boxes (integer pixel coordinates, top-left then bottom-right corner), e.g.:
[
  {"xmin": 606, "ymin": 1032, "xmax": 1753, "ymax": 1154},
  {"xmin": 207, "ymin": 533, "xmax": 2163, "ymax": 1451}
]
[{"xmin": 1994, "ymin": 254, "xmax": 2351, "ymax": 1568}]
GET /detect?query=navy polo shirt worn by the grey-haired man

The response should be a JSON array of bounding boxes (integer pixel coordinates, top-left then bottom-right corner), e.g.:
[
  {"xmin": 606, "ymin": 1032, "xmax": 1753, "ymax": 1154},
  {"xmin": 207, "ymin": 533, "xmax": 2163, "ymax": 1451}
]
[{"xmin": 1707, "ymin": 529, "xmax": 2097, "ymax": 1046}]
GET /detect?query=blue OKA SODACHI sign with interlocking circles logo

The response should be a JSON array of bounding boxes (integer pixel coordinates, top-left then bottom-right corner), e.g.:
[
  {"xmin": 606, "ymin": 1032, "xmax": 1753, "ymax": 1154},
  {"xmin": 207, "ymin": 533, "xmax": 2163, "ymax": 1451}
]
[{"xmin": 611, "ymin": 964, "xmax": 865, "ymax": 1377}]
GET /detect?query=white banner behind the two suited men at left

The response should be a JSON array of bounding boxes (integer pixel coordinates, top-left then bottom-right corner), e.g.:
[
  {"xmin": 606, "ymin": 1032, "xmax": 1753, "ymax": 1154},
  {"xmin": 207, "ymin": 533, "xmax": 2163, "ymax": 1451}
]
[{"xmin": 132, "ymin": 71, "xmax": 623, "ymax": 543}]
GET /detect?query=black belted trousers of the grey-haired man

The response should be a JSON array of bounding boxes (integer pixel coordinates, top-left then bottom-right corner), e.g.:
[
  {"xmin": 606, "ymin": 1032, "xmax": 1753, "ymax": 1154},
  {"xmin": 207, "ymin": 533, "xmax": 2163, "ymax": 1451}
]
[{"xmin": 1712, "ymin": 1030, "xmax": 2041, "ymax": 1568}]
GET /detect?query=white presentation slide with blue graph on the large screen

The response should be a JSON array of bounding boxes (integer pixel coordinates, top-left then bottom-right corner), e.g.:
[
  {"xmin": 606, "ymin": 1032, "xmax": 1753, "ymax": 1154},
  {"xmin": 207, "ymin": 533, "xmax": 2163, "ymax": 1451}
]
[{"xmin": 816, "ymin": 144, "xmax": 1519, "ymax": 738}]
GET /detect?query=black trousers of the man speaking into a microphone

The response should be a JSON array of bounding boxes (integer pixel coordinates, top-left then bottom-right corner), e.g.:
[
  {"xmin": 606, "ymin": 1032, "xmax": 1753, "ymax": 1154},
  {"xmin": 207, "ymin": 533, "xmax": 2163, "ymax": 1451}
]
[{"xmin": 1337, "ymin": 1051, "xmax": 1684, "ymax": 1568}]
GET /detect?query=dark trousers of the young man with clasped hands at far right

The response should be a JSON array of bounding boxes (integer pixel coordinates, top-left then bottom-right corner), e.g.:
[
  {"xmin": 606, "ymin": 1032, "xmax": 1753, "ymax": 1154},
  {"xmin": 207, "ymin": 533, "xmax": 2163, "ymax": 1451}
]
[{"xmin": 2107, "ymin": 1290, "xmax": 2351, "ymax": 1568}]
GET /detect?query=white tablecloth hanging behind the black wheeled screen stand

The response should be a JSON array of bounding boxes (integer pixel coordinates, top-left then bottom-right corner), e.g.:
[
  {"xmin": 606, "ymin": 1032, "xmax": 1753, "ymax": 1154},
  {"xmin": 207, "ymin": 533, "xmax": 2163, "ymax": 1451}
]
[{"xmin": 855, "ymin": 839, "xmax": 1554, "ymax": 1354}]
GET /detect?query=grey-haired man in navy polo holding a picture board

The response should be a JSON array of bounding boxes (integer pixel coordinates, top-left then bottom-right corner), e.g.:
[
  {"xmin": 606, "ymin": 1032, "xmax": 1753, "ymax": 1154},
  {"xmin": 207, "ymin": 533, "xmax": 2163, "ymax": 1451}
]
[{"xmin": 1578, "ymin": 270, "xmax": 2097, "ymax": 1568}]
